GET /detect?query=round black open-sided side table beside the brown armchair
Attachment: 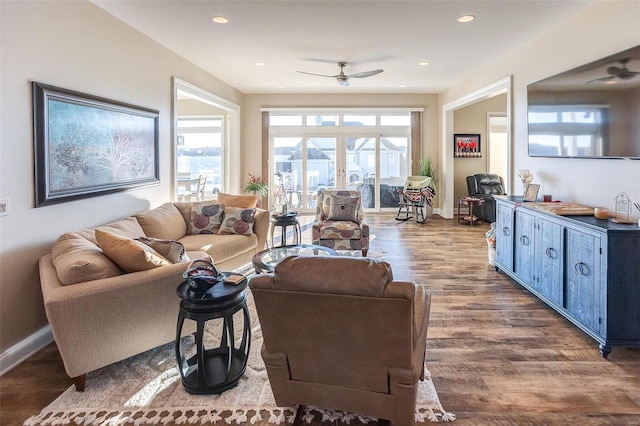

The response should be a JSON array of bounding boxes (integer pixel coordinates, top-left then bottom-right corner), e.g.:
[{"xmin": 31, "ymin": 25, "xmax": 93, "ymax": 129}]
[{"xmin": 176, "ymin": 272, "xmax": 251, "ymax": 394}]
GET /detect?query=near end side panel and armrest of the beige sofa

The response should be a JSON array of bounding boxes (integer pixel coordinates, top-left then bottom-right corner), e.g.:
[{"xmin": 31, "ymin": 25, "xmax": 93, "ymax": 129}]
[{"xmin": 39, "ymin": 254, "xmax": 188, "ymax": 377}]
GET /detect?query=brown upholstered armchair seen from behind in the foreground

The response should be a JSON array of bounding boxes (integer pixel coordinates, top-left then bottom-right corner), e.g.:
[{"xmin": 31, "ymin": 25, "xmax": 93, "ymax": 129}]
[{"xmin": 249, "ymin": 256, "xmax": 431, "ymax": 425}]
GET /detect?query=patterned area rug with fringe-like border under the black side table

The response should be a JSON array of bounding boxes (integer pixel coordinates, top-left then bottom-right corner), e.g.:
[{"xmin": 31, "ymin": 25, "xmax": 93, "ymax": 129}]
[{"xmin": 24, "ymin": 272, "xmax": 455, "ymax": 426}]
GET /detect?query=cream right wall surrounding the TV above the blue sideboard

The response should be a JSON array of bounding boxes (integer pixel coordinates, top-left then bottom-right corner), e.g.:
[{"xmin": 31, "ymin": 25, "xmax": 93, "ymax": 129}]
[{"xmin": 440, "ymin": 1, "xmax": 640, "ymax": 208}]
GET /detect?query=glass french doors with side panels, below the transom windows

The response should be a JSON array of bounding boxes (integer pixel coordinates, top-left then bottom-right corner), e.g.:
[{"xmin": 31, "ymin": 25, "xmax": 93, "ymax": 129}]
[{"xmin": 270, "ymin": 134, "xmax": 410, "ymax": 212}]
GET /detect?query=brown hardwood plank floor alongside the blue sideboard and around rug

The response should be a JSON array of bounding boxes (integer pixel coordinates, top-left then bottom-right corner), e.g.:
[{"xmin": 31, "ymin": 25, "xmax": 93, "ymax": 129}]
[{"xmin": 0, "ymin": 214, "xmax": 640, "ymax": 426}]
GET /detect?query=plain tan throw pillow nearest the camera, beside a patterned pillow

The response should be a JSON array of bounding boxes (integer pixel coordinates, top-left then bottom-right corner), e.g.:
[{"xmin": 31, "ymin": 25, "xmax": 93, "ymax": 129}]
[{"xmin": 96, "ymin": 229, "xmax": 171, "ymax": 272}]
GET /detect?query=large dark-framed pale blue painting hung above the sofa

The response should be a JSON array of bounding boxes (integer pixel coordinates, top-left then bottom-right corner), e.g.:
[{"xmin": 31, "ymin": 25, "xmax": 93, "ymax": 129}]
[{"xmin": 32, "ymin": 81, "xmax": 160, "ymax": 207}]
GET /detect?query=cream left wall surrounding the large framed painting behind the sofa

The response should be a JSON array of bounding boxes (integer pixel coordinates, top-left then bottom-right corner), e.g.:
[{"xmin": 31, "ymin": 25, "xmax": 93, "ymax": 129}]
[{"xmin": 0, "ymin": 1, "xmax": 242, "ymax": 353}]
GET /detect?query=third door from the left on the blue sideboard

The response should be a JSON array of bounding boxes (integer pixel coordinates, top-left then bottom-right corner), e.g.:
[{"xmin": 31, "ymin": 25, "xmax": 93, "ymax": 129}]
[{"xmin": 533, "ymin": 218, "xmax": 564, "ymax": 306}]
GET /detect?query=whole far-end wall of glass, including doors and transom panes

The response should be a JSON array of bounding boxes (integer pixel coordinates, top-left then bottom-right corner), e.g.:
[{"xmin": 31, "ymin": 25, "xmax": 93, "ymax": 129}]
[{"xmin": 269, "ymin": 110, "xmax": 411, "ymax": 212}]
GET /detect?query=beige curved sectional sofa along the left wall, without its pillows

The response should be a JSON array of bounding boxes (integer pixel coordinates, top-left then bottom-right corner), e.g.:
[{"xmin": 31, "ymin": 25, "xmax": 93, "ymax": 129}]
[{"xmin": 40, "ymin": 196, "xmax": 269, "ymax": 390}]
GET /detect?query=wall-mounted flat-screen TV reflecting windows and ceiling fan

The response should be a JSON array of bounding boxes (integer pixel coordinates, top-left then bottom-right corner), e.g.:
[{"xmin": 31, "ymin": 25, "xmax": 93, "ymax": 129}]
[{"xmin": 527, "ymin": 45, "xmax": 640, "ymax": 160}]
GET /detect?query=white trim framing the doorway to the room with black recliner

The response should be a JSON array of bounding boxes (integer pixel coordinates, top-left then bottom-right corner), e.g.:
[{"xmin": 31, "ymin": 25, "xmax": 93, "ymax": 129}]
[{"xmin": 440, "ymin": 76, "xmax": 513, "ymax": 219}]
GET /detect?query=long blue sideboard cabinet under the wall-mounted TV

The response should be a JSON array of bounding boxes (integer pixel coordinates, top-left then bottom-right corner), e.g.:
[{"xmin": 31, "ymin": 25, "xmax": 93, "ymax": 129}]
[{"xmin": 495, "ymin": 196, "xmax": 640, "ymax": 358}]
